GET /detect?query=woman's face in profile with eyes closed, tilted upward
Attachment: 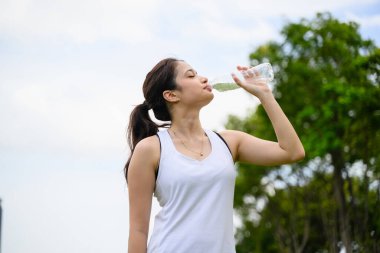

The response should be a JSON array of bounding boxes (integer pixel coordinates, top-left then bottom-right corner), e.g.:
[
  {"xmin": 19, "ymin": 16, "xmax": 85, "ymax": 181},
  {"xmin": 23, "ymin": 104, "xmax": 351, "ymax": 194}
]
[{"xmin": 175, "ymin": 61, "xmax": 214, "ymax": 106}]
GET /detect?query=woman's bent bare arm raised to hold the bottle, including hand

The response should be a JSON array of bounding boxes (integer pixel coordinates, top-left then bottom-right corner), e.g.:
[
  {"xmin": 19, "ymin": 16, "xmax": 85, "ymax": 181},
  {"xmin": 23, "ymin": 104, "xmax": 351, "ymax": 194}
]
[{"xmin": 221, "ymin": 67, "xmax": 305, "ymax": 166}]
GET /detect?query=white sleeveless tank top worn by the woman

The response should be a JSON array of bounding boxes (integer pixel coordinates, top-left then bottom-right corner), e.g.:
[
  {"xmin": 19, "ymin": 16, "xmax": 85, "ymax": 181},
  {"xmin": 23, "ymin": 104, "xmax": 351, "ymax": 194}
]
[{"xmin": 148, "ymin": 130, "xmax": 236, "ymax": 253}]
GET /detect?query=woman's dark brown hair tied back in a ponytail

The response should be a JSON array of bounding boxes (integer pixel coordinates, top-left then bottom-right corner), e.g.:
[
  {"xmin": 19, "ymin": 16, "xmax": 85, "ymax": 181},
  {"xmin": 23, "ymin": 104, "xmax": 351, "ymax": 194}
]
[{"xmin": 124, "ymin": 58, "xmax": 179, "ymax": 181}]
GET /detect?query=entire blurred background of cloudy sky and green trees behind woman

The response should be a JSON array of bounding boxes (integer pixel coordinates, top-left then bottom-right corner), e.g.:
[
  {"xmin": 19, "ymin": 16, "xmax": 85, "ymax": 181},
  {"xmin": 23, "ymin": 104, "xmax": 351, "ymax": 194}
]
[{"xmin": 0, "ymin": 0, "xmax": 380, "ymax": 253}]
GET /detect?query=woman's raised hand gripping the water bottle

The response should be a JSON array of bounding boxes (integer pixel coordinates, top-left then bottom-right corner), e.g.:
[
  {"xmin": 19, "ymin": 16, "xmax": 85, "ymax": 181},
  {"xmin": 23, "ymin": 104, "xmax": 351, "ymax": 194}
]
[{"xmin": 232, "ymin": 66, "xmax": 273, "ymax": 100}]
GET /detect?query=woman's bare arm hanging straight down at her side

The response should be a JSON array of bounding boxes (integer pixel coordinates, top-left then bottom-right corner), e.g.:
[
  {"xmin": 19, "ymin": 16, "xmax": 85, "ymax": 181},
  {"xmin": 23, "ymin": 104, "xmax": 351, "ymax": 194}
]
[{"xmin": 128, "ymin": 136, "xmax": 160, "ymax": 253}]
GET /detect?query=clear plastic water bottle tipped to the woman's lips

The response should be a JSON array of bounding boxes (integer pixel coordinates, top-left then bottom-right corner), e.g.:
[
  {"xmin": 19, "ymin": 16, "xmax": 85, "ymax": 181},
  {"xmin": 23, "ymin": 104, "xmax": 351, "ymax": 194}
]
[{"xmin": 211, "ymin": 63, "xmax": 274, "ymax": 92}]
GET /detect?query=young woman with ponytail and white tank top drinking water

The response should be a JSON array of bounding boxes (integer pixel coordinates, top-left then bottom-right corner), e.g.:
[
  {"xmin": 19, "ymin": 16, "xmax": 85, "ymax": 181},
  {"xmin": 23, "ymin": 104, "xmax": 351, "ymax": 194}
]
[{"xmin": 125, "ymin": 58, "xmax": 305, "ymax": 253}]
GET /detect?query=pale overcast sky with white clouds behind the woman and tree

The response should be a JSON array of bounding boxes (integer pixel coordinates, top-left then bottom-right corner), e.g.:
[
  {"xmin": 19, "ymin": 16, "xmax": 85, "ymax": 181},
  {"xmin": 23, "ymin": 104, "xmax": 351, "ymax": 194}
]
[{"xmin": 0, "ymin": 0, "xmax": 380, "ymax": 253}]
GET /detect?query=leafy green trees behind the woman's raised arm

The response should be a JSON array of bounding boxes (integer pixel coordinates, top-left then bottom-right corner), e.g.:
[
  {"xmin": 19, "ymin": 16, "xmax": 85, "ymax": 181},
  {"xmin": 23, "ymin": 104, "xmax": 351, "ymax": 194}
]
[{"xmin": 226, "ymin": 13, "xmax": 380, "ymax": 253}]
